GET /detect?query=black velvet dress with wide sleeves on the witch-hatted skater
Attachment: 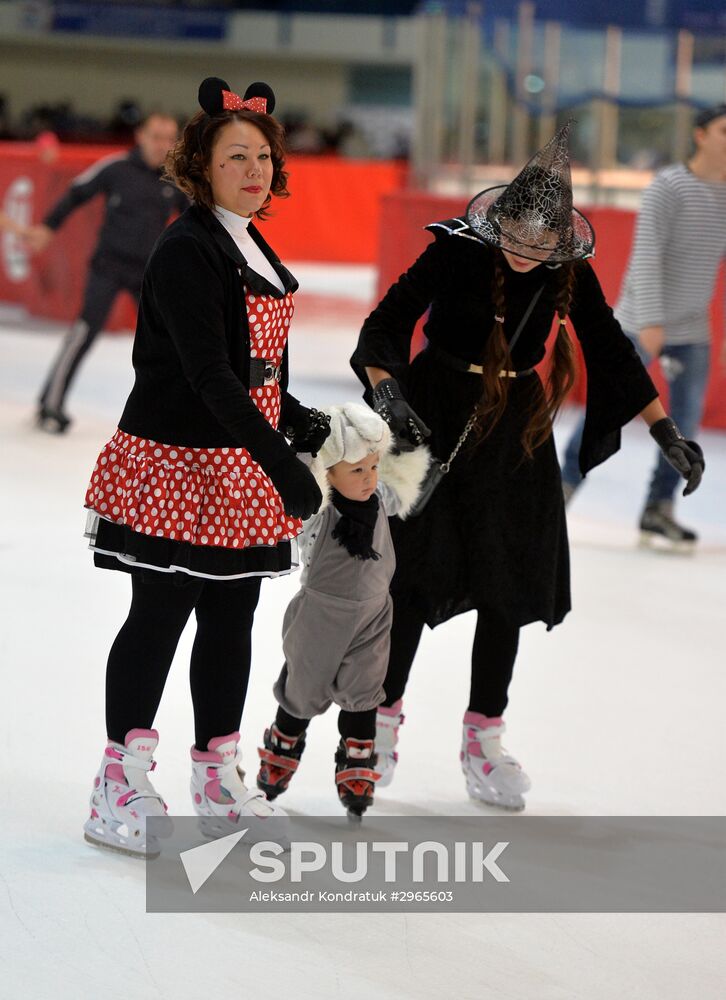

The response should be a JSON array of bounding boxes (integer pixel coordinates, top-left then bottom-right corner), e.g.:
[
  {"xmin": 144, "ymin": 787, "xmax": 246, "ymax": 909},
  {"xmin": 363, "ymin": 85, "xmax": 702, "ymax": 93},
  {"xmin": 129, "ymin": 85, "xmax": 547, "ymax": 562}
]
[{"xmin": 351, "ymin": 220, "xmax": 657, "ymax": 628}]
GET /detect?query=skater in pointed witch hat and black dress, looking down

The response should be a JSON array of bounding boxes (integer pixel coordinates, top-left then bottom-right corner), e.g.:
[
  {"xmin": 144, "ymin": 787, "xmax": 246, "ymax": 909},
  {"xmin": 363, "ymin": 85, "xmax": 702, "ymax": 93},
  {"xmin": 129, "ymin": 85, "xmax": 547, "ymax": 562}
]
[{"xmin": 352, "ymin": 122, "xmax": 704, "ymax": 809}]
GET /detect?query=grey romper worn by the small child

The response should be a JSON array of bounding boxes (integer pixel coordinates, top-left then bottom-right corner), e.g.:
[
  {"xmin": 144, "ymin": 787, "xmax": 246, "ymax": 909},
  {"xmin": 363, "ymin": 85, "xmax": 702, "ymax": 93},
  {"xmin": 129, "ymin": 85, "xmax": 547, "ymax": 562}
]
[{"xmin": 273, "ymin": 490, "xmax": 399, "ymax": 719}]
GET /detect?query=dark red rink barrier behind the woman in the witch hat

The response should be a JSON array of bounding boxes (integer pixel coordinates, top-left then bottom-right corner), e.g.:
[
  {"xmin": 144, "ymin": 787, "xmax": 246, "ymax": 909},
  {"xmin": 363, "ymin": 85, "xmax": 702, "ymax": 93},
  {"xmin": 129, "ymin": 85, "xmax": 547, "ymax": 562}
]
[{"xmin": 378, "ymin": 191, "xmax": 726, "ymax": 428}]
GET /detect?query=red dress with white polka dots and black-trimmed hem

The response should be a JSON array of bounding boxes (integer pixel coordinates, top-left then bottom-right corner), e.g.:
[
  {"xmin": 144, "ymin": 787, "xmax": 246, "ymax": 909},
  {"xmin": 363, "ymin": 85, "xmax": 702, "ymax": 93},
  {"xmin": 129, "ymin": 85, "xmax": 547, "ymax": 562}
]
[{"xmin": 86, "ymin": 293, "xmax": 301, "ymax": 578}]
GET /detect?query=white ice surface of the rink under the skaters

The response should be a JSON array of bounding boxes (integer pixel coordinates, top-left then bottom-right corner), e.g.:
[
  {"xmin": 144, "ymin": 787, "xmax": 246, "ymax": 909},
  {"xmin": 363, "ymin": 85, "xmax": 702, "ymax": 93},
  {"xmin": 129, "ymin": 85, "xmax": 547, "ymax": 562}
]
[{"xmin": 0, "ymin": 266, "xmax": 726, "ymax": 1000}]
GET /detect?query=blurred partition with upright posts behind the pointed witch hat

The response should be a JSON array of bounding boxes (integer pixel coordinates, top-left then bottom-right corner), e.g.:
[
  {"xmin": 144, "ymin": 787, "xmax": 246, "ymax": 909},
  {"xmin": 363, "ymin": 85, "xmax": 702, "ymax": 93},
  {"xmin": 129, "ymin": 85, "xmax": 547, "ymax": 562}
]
[{"xmin": 412, "ymin": 0, "xmax": 726, "ymax": 204}]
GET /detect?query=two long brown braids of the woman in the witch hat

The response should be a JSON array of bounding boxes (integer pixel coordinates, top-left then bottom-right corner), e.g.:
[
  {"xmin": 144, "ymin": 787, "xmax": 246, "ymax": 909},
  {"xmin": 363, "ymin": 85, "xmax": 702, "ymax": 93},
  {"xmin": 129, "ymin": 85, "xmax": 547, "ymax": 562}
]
[{"xmin": 477, "ymin": 251, "xmax": 576, "ymax": 458}]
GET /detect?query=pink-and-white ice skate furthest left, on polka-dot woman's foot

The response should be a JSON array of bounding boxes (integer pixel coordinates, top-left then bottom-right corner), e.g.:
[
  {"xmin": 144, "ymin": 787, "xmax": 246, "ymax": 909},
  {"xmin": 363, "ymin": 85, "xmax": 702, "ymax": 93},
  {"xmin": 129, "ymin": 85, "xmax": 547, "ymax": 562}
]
[{"xmin": 83, "ymin": 729, "xmax": 172, "ymax": 858}]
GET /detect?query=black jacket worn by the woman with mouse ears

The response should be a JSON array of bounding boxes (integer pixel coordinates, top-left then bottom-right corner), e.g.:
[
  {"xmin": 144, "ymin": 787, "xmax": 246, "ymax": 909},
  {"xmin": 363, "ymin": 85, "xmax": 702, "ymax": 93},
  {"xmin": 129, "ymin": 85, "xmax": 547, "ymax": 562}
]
[{"xmin": 119, "ymin": 206, "xmax": 304, "ymax": 472}]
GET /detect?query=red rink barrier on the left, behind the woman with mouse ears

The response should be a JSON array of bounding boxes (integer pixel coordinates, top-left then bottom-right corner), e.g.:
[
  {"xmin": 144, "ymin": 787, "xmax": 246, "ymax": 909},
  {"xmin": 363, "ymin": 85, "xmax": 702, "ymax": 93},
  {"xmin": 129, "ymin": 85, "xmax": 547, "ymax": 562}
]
[{"xmin": 0, "ymin": 143, "xmax": 406, "ymax": 330}]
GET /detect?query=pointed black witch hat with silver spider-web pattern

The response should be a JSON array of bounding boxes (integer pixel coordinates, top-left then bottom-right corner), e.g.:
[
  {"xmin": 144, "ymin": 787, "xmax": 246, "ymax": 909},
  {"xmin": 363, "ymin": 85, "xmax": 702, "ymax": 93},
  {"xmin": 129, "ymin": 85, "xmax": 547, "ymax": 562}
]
[{"xmin": 466, "ymin": 119, "xmax": 595, "ymax": 264}]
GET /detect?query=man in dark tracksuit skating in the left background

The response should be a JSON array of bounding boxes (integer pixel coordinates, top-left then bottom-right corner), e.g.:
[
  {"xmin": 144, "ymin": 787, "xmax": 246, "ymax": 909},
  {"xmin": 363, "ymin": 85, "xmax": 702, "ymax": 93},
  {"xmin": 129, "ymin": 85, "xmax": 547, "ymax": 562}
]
[{"xmin": 24, "ymin": 113, "xmax": 189, "ymax": 434}]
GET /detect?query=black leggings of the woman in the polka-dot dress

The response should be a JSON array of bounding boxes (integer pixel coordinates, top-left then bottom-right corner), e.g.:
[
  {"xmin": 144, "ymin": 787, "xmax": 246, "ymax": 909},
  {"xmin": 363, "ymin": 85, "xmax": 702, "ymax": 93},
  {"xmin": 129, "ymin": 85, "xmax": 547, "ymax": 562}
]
[{"xmin": 106, "ymin": 571, "xmax": 260, "ymax": 750}]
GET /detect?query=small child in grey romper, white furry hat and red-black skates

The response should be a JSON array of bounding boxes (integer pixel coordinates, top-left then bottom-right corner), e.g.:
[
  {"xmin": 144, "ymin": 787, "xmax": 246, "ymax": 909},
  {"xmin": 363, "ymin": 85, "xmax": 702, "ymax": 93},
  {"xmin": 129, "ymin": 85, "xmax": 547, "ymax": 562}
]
[{"xmin": 257, "ymin": 403, "xmax": 429, "ymax": 820}]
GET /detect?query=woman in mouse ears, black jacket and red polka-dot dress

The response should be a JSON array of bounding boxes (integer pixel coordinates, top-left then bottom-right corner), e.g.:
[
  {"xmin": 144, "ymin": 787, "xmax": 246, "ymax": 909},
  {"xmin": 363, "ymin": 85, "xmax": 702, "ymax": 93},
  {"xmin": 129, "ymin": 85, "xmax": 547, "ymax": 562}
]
[{"xmin": 80, "ymin": 78, "xmax": 328, "ymax": 857}]
